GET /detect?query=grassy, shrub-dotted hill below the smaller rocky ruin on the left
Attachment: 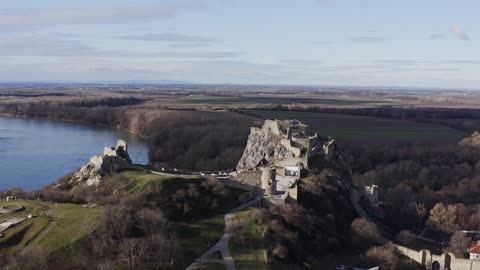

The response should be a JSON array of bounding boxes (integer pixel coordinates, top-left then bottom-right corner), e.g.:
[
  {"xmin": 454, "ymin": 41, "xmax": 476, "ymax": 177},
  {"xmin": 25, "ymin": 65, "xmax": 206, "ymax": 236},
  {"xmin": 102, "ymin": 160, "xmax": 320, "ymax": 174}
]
[{"xmin": 0, "ymin": 170, "xmax": 250, "ymax": 269}]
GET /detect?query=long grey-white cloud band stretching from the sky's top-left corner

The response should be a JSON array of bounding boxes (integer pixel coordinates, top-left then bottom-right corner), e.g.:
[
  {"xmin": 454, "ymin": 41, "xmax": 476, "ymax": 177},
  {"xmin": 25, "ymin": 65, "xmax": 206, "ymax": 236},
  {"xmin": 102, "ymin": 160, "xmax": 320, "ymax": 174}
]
[{"xmin": 0, "ymin": 2, "xmax": 203, "ymax": 32}]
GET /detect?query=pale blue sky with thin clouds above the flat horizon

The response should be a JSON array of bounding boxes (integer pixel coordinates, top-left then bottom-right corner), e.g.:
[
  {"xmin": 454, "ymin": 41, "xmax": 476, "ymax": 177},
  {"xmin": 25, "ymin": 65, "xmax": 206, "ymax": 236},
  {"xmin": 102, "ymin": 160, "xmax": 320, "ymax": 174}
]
[{"xmin": 0, "ymin": 0, "xmax": 480, "ymax": 89}]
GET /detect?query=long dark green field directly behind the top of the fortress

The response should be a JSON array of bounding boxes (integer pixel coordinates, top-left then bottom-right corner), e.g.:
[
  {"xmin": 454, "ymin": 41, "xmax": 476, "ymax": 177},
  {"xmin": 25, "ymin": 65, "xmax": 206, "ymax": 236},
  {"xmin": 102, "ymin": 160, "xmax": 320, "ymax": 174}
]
[{"xmin": 244, "ymin": 110, "xmax": 468, "ymax": 144}]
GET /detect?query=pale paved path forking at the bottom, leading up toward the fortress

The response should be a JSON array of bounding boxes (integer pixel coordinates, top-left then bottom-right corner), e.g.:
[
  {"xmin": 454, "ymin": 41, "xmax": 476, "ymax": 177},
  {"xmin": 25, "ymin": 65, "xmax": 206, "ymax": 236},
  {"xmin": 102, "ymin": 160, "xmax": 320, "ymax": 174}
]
[{"xmin": 187, "ymin": 198, "xmax": 260, "ymax": 270}]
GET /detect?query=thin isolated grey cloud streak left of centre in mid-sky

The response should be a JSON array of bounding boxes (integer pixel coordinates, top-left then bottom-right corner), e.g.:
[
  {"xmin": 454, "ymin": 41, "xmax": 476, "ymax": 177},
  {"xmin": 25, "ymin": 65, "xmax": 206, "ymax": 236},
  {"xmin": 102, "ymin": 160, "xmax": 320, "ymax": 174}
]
[{"xmin": 118, "ymin": 33, "xmax": 219, "ymax": 43}]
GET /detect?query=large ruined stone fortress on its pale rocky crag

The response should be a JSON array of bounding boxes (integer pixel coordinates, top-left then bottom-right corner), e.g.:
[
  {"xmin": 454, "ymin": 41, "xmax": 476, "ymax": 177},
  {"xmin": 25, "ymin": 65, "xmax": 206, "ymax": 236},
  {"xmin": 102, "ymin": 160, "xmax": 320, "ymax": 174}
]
[{"xmin": 235, "ymin": 120, "xmax": 335, "ymax": 201}]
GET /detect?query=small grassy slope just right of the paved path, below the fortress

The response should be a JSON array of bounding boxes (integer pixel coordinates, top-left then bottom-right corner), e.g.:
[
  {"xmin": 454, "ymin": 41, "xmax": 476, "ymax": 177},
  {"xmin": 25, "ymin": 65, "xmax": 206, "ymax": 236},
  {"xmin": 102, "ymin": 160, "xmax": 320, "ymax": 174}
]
[{"xmin": 230, "ymin": 208, "xmax": 267, "ymax": 270}]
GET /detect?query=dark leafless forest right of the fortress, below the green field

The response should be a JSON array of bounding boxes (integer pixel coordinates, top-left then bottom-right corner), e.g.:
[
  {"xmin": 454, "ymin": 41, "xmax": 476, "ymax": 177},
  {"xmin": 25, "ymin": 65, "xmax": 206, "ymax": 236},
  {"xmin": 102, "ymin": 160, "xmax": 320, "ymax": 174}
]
[{"xmin": 346, "ymin": 145, "xmax": 480, "ymax": 232}]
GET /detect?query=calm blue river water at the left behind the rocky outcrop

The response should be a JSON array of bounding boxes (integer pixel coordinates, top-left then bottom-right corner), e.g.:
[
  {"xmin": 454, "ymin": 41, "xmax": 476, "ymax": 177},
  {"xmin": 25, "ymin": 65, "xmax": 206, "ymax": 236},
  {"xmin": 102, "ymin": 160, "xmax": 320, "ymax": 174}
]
[{"xmin": 0, "ymin": 116, "xmax": 148, "ymax": 190}]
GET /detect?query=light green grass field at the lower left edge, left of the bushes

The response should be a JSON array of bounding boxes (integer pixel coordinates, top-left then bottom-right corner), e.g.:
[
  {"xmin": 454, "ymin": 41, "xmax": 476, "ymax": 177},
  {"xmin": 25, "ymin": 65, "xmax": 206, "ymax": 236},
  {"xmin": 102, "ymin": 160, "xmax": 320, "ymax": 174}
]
[{"xmin": 0, "ymin": 200, "xmax": 102, "ymax": 253}]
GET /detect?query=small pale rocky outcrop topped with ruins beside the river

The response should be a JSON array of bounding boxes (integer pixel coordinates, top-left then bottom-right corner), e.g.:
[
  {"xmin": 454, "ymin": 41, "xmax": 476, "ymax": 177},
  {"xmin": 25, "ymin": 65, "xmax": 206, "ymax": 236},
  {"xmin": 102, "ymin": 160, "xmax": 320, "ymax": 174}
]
[{"xmin": 69, "ymin": 140, "xmax": 132, "ymax": 186}]
